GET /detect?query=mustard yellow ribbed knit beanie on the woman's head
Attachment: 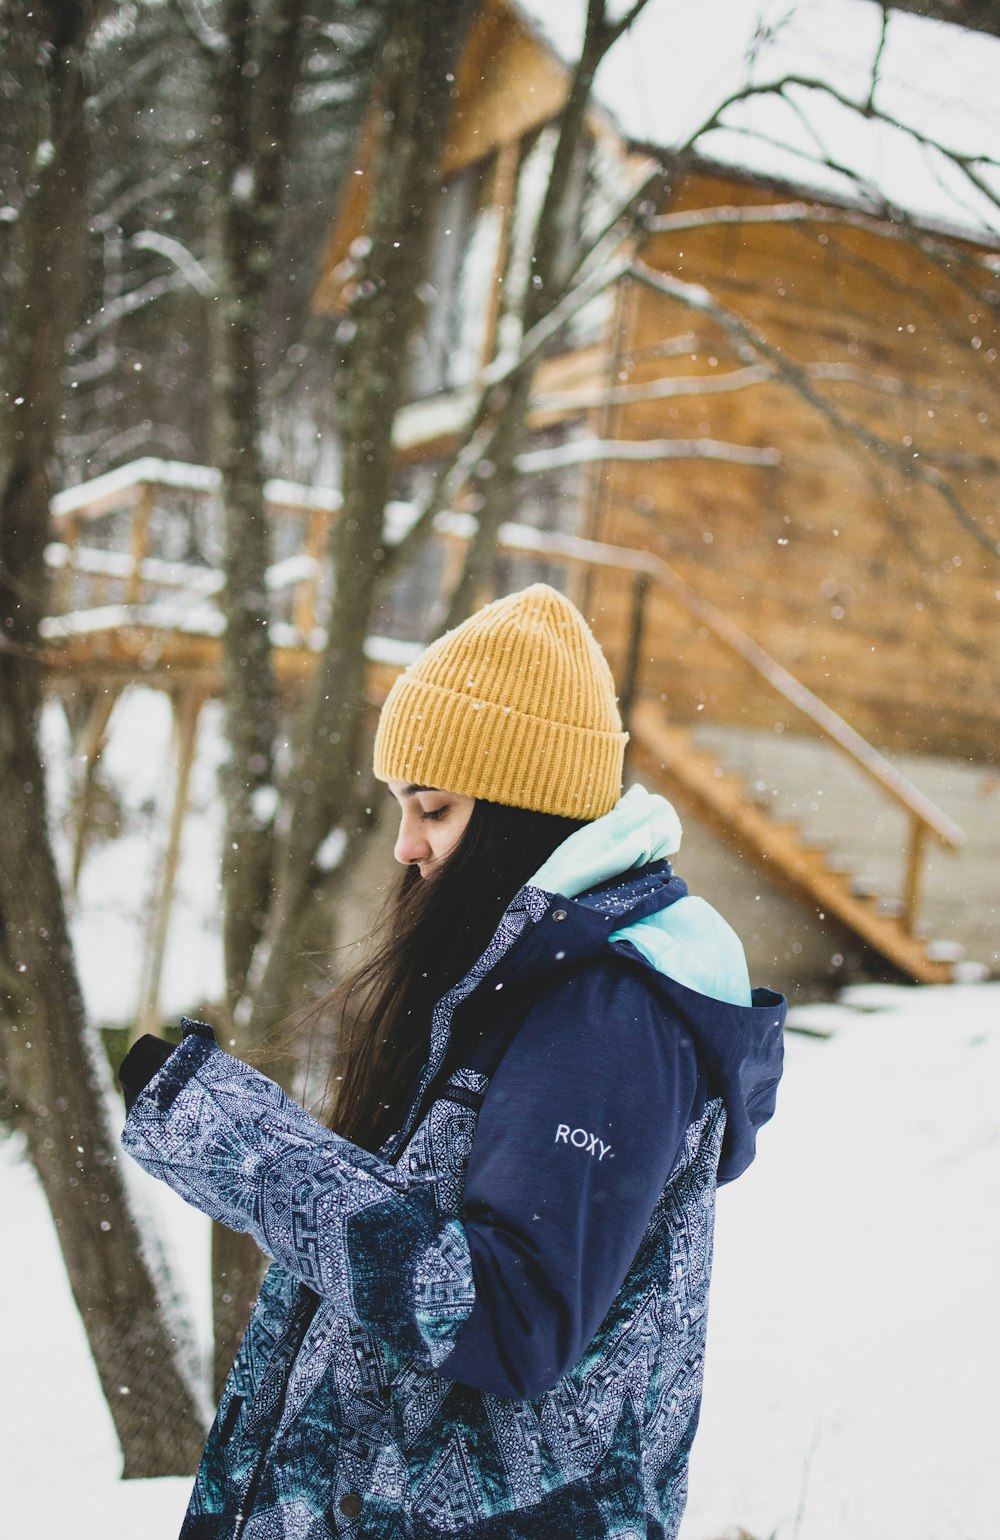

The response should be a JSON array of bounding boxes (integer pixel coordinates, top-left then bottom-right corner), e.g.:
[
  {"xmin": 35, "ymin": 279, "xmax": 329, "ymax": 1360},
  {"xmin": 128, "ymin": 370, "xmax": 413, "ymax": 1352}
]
[{"xmin": 374, "ymin": 582, "xmax": 629, "ymax": 819}]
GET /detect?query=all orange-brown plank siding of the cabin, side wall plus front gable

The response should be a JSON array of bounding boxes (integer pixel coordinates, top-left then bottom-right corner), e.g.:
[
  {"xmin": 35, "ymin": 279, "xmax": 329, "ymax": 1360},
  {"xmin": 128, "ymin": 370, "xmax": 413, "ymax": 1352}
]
[{"xmin": 316, "ymin": 0, "xmax": 1000, "ymax": 762}]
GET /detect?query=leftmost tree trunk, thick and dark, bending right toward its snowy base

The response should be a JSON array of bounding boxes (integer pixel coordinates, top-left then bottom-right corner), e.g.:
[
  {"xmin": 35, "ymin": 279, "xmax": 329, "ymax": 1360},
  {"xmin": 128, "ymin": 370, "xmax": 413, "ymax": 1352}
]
[{"xmin": 0, "ymin": 12, "xmax": 205, "ymax": 1475}]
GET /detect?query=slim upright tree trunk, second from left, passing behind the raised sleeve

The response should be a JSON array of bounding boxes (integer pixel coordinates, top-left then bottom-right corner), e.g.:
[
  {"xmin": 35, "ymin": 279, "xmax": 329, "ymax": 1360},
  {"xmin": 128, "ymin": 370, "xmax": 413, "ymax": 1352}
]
[{"xmin": 201, "ymin": 0, "xmax": 311, "ymax": 1373}]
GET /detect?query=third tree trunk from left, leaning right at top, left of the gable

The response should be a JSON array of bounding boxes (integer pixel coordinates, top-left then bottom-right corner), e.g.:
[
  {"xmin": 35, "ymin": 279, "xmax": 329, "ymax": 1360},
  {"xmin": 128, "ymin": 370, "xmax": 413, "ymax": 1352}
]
[{"xmin": 240, "ymin": 0, "xmax": 475, "ymax": 1043}]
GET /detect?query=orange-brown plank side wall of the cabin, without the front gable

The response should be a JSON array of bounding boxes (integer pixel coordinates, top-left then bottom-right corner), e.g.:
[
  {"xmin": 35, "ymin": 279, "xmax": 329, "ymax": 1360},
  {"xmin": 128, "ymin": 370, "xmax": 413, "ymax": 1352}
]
[{"xmin": 586, "ymin": 174, "xmax": 1000, "ymax": 759}]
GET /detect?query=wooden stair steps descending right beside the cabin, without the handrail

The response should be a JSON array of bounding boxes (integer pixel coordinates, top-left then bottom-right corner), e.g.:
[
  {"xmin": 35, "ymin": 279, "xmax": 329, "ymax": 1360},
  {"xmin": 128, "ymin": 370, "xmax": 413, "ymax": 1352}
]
[{"xmin": 629, "ymin": 699, "xmax": 952, "ymax": 984}]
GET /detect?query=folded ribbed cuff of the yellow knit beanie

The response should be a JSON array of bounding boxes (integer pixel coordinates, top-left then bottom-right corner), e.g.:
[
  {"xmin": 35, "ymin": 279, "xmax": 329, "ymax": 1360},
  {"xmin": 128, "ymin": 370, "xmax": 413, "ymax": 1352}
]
[{"xmin": 374, "ymin": 673, "xmax": 629, "ymax": 819}]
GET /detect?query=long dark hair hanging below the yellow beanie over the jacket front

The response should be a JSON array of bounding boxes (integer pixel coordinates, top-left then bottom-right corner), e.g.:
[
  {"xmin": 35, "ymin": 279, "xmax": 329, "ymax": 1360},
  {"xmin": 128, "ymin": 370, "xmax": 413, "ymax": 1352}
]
[{"xmin": 324, "ymin": 801, "xmax": 584, "ymax": 1150}]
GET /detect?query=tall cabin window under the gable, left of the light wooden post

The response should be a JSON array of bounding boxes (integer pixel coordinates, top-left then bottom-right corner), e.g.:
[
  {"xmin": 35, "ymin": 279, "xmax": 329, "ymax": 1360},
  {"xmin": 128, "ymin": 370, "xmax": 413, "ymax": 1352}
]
[{"xmin": 410, "ymin": 159, "xmax": 501, "ymax": 400}]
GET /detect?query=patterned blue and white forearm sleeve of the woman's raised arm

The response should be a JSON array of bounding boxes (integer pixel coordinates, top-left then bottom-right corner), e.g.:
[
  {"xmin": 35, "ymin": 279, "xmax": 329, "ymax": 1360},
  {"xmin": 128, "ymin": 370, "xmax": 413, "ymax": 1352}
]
[{"xmin": 122, "ymin": 1021, "xmax": 473, "ymax": 1368}]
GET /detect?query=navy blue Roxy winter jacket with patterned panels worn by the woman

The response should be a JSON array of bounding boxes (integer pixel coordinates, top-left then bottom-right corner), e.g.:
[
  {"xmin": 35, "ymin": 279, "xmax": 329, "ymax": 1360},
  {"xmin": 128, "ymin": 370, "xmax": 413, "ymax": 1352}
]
[{"xmin": 123, "ymin": 861, "xmax": 784, "ymax": 1540}]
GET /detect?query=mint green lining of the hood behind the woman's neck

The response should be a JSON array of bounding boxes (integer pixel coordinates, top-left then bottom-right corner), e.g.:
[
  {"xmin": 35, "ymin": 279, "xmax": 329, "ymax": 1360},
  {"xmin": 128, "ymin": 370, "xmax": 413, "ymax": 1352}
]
[{"xmin": 530, "ymin": 785, "xmax": 750, "ymax": 1006}]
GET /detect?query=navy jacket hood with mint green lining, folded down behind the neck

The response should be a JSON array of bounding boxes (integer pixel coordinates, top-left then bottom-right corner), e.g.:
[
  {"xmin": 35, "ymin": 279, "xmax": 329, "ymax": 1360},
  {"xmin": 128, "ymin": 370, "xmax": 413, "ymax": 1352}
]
[{"xmin": 530, "ymin": 785, "xmax": 786, "ymax": 1181}]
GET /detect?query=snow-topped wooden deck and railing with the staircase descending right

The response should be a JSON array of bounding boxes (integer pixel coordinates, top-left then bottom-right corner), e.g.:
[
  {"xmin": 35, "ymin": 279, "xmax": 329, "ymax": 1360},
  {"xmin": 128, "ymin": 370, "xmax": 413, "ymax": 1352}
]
[{"xmin": 43, "ymin": 460, "xmax": 965, "ymax": 992}]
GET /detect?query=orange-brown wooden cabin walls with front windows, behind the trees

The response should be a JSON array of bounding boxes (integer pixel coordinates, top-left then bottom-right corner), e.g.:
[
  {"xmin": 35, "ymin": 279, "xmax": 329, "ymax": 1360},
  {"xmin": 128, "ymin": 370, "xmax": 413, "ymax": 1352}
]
[{"xmin": 308, "ymin": 0, "xmax": 1000, "ymax": 976}]
